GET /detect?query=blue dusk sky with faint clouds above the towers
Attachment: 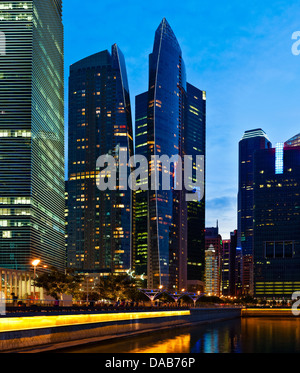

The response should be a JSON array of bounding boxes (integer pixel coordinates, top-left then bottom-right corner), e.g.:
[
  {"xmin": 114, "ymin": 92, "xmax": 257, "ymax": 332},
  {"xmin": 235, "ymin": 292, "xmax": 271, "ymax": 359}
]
[{"xmin": 64, "ymin": 0, "xmax": 300, "ymax": 238}]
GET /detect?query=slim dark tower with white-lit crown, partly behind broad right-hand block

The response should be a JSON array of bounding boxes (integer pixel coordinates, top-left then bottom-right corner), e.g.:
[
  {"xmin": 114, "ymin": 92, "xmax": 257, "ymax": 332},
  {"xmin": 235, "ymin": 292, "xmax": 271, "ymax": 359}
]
[{"xmin": 238, "ymin": 129, "xmax": 271, "ymax": 294}]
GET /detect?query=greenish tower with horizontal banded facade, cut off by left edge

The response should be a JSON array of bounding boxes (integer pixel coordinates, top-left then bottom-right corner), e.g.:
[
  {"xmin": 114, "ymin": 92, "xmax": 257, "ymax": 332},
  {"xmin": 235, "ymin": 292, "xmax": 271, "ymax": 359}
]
[{"xmin": 0, "ymin": 0, "xmax": 65, "ymax": 271}]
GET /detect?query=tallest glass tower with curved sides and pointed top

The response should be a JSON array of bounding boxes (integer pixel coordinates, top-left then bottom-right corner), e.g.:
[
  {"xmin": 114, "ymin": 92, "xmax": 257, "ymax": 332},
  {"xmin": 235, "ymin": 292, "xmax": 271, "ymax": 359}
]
[{"xmin": 147, "ymin": 18, "xmax": 186, "ymax": 288}]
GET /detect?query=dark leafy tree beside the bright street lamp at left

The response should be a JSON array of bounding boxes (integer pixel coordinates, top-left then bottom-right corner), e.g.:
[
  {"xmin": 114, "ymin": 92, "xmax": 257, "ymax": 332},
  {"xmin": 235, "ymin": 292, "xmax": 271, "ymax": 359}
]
[{"xmin": 33, "ymin": 267, "xmax": 82, "ymax": 300}]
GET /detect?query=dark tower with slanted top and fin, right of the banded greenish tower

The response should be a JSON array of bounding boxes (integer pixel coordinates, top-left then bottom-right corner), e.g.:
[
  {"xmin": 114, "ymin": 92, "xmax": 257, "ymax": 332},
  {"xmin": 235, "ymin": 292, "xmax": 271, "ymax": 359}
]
[{"xmin": 67, "ymin": 44, "xmax": 133, "ymax": 274}]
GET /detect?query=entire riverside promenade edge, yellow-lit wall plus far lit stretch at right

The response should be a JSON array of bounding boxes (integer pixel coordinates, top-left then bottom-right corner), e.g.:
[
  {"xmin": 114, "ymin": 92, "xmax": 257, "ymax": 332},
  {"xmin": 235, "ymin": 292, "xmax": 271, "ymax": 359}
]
[{"xmin": 0, "ymin": 305, "xmax": 294, "ymax": 352}]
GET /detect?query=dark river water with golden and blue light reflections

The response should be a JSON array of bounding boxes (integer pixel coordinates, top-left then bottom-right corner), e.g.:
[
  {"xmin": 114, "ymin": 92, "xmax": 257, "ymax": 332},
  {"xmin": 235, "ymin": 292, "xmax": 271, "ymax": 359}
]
[{"xmin": 63, "ymin": 317, "xmax": 300, "ymax": 353}]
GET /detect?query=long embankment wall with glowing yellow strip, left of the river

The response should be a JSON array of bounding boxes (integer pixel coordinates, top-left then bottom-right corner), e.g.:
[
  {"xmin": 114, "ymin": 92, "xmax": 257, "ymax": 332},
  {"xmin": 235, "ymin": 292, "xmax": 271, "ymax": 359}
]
[{"xmin": 0, "ymin": 308, "xmax": 241, "ymax": 352}]
